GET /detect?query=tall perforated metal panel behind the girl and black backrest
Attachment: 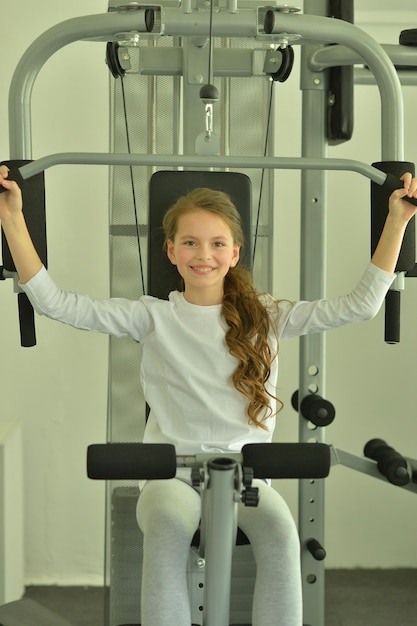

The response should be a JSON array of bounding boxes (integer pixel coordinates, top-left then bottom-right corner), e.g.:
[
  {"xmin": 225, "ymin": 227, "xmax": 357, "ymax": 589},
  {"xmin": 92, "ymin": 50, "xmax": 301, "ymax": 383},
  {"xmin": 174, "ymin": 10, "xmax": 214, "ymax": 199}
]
[{"xmin": 106, "ymin": 25, "xmax": 272, "ymax": 626}]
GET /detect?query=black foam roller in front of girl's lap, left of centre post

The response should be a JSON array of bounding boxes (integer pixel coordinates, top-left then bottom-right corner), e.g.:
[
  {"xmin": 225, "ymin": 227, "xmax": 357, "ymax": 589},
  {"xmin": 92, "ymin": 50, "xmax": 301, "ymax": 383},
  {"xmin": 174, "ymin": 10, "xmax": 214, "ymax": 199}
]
[{"xmin": 87, "ymin": 443, "xmax": 177, "ymax": 480}]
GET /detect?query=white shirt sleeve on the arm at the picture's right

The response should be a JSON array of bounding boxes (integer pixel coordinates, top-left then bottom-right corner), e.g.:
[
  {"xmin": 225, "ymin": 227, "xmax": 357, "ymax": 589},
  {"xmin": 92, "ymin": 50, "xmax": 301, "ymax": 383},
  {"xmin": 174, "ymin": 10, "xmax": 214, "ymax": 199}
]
[{"xmin": 277, "ymin": 263, "xmax": 395, "ymax": 339}]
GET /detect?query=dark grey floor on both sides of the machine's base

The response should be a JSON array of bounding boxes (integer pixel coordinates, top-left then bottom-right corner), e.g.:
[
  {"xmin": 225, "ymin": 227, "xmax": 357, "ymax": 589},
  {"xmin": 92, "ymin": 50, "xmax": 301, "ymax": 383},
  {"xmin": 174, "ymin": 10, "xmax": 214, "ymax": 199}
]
[{"xmin": 22, "ymin": 569, "xmax": 417, "ymax": 626}]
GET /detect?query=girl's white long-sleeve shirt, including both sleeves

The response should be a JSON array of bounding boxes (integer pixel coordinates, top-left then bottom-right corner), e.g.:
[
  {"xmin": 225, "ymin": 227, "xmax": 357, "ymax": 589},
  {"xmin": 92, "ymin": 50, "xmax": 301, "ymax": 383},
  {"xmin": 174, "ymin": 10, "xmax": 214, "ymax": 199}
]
[{"xmin": 22, "ymin": 263, "xmax": 394, "ymax": 454}]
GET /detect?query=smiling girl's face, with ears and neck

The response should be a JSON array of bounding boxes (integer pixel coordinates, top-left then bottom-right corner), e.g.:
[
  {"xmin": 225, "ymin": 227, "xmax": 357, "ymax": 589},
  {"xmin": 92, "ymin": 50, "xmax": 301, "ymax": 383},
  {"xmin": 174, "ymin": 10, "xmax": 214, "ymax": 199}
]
[{"xmin": 167, "ymin": 209, "xmax": 240, "ymax": 306}]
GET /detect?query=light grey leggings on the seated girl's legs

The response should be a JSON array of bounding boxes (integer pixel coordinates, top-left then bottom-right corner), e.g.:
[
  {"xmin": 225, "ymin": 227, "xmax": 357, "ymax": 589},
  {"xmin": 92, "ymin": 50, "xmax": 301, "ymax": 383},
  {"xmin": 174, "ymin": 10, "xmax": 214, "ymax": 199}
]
[{"xmin": 137, "ymin": 478, "xmax": 302, "ymax": 626}]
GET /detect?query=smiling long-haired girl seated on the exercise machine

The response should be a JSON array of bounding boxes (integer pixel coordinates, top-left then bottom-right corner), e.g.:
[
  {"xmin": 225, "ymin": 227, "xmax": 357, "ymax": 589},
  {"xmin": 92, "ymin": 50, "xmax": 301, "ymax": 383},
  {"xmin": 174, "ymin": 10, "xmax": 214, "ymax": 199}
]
[{"xmin": 0, "ymin": 166, "xmax": 417, "ymax": 626}]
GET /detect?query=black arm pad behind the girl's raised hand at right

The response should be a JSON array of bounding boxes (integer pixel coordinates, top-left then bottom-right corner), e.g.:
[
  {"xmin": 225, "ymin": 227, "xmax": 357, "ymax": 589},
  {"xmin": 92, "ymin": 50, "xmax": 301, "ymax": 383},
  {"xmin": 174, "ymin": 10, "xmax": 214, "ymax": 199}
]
[{"xmin": 371, "ymin": 161, "xmax": 416, "ymax": 272}]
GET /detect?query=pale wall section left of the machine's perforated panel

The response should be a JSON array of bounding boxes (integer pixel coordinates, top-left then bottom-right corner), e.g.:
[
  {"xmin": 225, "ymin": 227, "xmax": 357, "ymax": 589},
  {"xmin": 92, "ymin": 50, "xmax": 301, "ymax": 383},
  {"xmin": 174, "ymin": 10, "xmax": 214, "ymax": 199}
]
[{"xmin": 0, "ymin": 0, "xmax": 108, "ymax": 584}]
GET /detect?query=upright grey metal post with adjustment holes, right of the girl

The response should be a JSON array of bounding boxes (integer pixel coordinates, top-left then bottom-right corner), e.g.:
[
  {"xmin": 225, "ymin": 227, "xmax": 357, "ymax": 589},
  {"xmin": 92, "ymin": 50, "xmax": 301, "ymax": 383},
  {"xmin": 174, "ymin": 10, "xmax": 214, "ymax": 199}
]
[{"xmin": 298, "ymin": 0, "xmax": 327, "ymax": 626}]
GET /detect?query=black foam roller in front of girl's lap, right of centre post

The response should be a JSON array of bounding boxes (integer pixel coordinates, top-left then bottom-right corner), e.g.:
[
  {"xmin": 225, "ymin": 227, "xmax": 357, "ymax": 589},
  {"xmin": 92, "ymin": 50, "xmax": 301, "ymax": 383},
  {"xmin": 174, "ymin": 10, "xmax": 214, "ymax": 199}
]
[{"xmin": 242, "ymin": 443, "xmax": 330, "ymax": 478}]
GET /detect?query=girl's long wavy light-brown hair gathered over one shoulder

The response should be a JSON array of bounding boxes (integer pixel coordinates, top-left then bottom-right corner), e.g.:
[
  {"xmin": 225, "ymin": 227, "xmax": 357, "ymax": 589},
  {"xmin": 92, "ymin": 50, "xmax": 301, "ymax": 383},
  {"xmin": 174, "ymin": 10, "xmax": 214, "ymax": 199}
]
[{"xmin": 162, "ymin": 188, "xmax": 283, "ymax": 429}]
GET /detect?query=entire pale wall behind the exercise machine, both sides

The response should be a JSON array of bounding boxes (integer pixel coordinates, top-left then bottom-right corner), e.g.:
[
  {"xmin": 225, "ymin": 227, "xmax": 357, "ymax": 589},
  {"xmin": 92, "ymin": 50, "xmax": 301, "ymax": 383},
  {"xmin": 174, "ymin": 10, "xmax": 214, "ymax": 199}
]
[{"xmin": 0, "ymin": 0, "xmax": 417, "ymax": 585}]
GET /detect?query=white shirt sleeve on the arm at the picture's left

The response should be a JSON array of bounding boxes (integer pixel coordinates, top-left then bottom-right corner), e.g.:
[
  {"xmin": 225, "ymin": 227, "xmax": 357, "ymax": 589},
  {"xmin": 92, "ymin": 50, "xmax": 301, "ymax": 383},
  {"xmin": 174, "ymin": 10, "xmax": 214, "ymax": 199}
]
[{"xmin": 20, "ymin": 267, "xmax": 152, "ymax": 341}]
